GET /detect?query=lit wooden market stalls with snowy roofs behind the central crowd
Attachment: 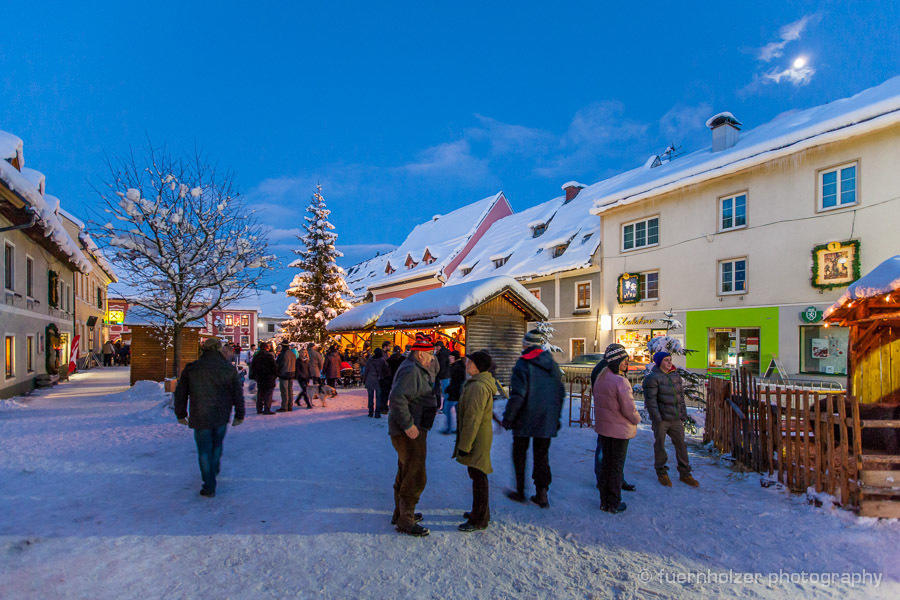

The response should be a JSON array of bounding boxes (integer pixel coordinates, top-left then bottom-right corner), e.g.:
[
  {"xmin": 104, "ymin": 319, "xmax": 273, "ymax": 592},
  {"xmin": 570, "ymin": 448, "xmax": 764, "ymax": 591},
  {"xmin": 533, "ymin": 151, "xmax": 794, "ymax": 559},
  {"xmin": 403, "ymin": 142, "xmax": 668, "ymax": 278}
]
[{"xmin": 328, "ymin": 277, "xmax": 549, "ymax": 384}]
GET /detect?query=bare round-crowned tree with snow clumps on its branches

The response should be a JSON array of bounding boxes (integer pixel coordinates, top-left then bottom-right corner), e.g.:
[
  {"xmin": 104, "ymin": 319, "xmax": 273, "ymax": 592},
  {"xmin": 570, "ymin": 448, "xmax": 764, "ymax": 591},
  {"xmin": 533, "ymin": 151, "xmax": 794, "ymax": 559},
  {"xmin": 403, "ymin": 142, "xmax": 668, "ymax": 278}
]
[{"xmin": 96, "ymin": 147, "xmax": 272, "ymax": 374}]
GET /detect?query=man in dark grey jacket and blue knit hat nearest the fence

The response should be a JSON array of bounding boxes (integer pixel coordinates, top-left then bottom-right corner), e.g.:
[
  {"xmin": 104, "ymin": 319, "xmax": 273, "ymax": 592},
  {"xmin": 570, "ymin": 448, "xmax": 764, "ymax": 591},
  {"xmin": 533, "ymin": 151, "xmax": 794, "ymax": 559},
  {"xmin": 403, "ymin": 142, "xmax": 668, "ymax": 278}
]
[{"xmin": 644, "ymin": 352, "xmax": 700, "ymax": 487}]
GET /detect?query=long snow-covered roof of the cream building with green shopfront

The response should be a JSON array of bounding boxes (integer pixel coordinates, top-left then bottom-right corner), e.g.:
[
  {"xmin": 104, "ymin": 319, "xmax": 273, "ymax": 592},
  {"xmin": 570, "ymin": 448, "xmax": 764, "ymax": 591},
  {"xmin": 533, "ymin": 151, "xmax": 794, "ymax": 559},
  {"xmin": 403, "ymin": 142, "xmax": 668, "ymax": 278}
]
[{"xmin": 592, "ymin": 76, "xmax": 900, "ymax": 214}]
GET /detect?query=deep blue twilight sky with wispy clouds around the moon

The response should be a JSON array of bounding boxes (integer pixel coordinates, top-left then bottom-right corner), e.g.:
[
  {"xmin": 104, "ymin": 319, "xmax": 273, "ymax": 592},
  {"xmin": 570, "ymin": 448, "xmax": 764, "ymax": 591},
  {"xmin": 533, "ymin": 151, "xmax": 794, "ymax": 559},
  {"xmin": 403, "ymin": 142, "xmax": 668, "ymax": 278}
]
[{"xmin": 0, "ymin": 0, "xmax": 900, "ymax": 286}]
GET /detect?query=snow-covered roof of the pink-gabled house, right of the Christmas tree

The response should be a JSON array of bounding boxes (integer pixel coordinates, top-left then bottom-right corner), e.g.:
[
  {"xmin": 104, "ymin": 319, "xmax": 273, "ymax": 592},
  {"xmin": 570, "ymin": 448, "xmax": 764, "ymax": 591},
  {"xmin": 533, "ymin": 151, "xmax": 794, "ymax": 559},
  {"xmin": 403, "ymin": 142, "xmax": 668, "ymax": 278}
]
[{"xmin": 346, "ymin": 192, "xmax": 506, "ymax": 298}]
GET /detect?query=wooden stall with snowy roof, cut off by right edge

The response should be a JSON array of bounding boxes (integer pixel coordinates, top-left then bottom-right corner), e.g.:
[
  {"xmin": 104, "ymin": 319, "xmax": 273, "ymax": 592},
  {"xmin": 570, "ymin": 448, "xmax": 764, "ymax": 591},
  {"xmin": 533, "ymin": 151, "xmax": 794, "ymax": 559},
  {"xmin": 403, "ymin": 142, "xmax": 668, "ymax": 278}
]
[{"xmin": 825, "ymin": 255, "xmax": 900, "ymax": 518}]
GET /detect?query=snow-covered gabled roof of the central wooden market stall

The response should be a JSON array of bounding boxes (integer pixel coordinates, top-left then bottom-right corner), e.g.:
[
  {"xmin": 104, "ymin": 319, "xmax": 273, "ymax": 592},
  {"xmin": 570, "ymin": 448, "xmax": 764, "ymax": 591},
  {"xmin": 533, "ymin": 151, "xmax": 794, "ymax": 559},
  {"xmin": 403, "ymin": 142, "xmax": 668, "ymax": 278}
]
[{"xmin": 376, "ymin": 276, "xmax": 550, "ymax": 329}]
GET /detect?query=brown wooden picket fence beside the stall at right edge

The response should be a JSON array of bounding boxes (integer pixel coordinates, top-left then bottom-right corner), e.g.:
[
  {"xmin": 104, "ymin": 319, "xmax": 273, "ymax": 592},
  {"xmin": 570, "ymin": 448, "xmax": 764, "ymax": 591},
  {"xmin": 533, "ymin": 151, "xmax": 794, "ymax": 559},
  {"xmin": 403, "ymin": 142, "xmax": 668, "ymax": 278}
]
[{"xmin": 703, "ymin": 369, "xmax": 900, "ymax": 518}]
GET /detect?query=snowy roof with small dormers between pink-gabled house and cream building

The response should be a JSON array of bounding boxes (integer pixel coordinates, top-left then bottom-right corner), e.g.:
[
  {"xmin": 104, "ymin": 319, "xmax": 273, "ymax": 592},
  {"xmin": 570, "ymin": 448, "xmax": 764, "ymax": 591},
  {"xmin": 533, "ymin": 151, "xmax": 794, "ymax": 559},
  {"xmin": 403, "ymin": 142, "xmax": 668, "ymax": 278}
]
[{"xmin": 448, "ymin": 180, "xmax": 600, "ymax": 284}]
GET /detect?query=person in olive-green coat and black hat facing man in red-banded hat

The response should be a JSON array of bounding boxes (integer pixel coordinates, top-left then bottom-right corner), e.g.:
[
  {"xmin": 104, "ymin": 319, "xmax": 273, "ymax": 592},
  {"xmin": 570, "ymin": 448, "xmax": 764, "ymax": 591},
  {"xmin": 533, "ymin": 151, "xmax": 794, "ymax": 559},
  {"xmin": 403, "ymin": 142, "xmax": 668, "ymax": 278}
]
[{"xmin": 453, "ymin": 350, "xmax": 497, "ymax": 531}]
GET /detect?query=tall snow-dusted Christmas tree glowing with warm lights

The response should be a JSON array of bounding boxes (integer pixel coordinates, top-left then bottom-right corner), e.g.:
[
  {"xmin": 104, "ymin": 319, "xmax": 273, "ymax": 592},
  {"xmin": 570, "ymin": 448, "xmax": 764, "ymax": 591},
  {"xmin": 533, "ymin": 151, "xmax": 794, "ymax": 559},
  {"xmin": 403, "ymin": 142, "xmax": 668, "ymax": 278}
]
[{"xmin": 281, "ymin": 185, "xmax": 350, "ymax": 344}]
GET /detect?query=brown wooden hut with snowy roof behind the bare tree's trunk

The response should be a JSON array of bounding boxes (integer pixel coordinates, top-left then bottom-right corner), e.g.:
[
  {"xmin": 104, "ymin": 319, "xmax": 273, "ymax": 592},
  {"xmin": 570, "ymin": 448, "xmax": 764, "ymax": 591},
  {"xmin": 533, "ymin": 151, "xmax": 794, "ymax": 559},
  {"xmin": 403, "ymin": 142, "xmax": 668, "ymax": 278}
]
[{"xmin": 124, "ymin": 306, "xmax": 204, "ymax": 385}]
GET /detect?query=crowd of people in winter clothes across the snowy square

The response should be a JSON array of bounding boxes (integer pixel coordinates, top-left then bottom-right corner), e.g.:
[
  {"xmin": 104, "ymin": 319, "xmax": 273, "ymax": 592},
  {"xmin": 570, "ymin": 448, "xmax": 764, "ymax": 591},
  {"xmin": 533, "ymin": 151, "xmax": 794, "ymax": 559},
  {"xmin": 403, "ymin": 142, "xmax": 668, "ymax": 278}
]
[{"xmin": 175, "ymin": 330, "xmax": 699, "ymax": 536}]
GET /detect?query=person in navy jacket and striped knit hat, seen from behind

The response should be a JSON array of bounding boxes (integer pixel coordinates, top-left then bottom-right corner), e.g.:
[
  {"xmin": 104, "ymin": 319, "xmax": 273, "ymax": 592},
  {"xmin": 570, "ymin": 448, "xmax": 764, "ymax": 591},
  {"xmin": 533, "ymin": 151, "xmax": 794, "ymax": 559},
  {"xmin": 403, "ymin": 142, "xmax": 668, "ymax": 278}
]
[{"xmin": 503, "ymin": 329, "xmax": 566, "ymax": 508}]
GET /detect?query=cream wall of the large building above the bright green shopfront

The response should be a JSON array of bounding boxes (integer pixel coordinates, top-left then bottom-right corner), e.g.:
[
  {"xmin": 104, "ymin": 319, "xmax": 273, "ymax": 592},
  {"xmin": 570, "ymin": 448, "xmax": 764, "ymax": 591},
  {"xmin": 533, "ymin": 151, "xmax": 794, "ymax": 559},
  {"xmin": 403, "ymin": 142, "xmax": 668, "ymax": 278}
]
[{"xmin": 603, "ymin": 126, "xmax": 900, "ymax": 373}]
